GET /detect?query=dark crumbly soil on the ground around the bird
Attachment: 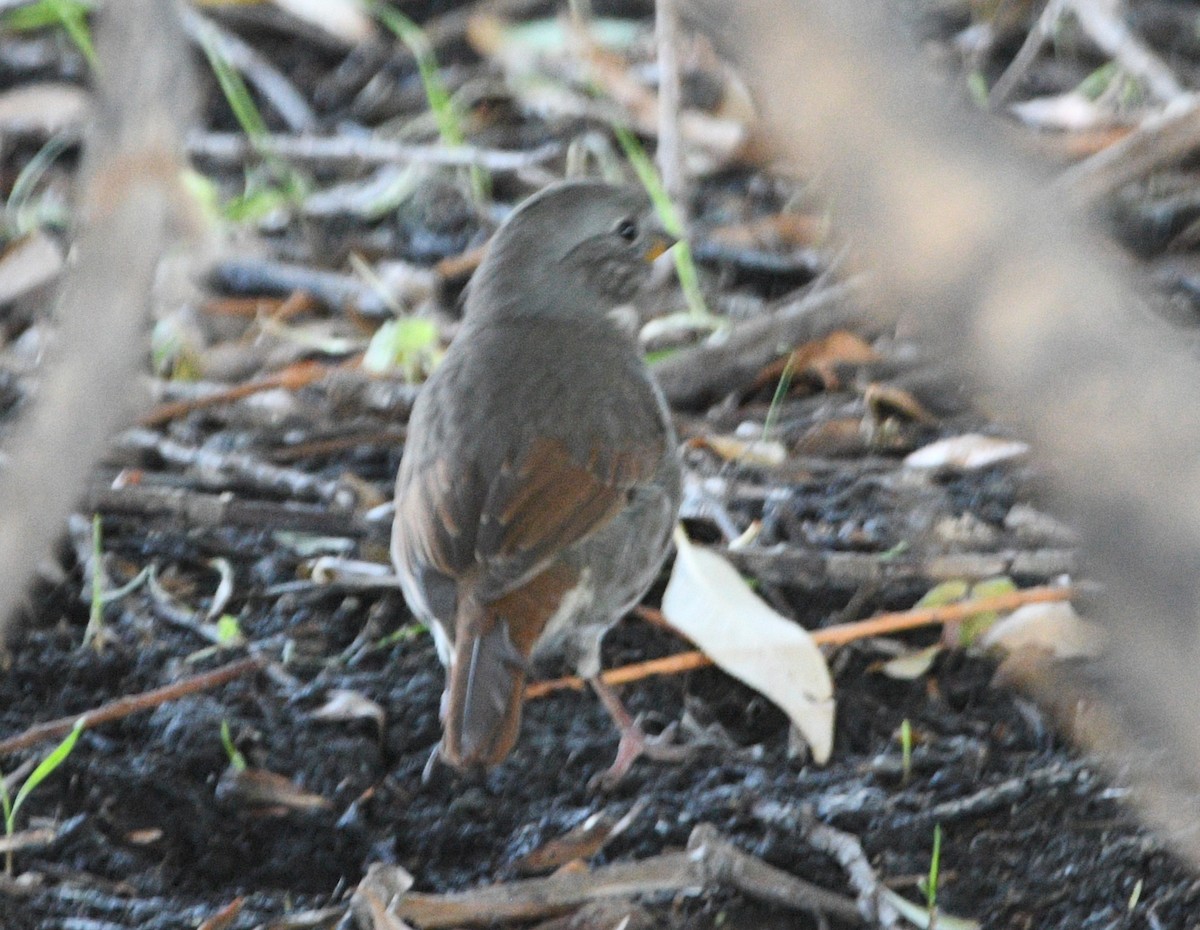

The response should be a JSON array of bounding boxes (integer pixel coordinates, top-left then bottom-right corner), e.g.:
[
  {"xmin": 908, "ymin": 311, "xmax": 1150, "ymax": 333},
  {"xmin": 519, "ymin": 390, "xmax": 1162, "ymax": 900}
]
[{"xmin": 0, "ymin": 4, "xmax": 1200, "ymax": 930}]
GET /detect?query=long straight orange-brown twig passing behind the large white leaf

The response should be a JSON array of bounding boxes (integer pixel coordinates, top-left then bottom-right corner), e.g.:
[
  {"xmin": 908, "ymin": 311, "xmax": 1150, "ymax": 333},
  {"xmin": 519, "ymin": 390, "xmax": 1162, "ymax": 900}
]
[{"xmin": 526, "ymin": 587, "xmax": 1074, "ymax": 700}]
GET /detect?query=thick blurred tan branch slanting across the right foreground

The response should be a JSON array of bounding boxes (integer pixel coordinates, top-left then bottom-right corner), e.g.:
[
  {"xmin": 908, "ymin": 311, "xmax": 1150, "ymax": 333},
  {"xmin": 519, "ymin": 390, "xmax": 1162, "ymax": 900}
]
[{"xmin": 697, "ymin": 0, "xmax": 1200, "ymax": 862}]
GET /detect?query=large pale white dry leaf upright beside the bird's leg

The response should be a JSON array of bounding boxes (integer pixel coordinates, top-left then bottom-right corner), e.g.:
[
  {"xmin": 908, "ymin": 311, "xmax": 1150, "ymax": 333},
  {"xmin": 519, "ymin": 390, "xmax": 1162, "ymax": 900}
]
[{"xmin": 662, "ymin": 529, "xmax": 834, "ymax": 764}]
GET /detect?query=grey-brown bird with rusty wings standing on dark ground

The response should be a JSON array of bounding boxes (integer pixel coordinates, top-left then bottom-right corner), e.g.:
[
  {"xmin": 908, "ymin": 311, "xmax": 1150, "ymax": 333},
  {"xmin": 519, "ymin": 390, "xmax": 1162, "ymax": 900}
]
[{"xmin": 391, "ymin": 180, "xmax": 682, "ymax": 780}]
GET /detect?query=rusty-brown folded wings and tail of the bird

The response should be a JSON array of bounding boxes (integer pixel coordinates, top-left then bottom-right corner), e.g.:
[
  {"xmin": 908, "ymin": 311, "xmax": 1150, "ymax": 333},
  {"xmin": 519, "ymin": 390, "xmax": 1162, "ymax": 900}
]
[{"xmin": 392, "ymin": 388, "xmax": 666, "ymax": 767}]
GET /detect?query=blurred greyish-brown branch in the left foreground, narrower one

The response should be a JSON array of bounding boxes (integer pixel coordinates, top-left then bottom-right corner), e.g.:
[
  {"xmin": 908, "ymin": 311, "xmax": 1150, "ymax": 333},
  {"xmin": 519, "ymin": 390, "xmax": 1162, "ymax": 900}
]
[{"xmin": 0, "ymin": 0, "xmax": 194, "ymax": 640}]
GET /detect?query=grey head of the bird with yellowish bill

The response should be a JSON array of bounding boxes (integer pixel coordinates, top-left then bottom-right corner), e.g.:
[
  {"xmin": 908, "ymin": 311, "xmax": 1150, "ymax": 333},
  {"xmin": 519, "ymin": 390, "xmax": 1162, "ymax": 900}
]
[{"xmin": 467, "ymin": 181, "xmax": 674, "ymax": 317}]
